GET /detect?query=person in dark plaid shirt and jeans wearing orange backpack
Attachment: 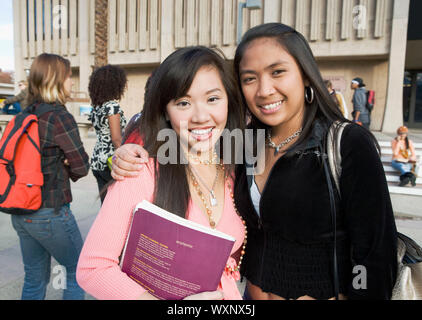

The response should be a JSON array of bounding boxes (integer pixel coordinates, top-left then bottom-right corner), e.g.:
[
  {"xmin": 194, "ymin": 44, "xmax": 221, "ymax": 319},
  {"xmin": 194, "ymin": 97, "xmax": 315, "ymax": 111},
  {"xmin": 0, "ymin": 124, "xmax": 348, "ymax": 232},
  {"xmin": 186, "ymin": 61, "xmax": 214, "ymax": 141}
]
[{"xmin": 12, "ymin": 53, "xmax": 89, "ymax": 300}]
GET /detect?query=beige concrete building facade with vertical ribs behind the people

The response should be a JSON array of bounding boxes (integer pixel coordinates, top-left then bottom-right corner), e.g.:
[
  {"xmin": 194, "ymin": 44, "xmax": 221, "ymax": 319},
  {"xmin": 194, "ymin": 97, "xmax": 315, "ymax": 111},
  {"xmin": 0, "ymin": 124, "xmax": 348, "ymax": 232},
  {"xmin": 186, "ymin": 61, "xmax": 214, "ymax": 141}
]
[{"xmin": 13, "ymin": 0, "xmax": 419, "ymax": 132}]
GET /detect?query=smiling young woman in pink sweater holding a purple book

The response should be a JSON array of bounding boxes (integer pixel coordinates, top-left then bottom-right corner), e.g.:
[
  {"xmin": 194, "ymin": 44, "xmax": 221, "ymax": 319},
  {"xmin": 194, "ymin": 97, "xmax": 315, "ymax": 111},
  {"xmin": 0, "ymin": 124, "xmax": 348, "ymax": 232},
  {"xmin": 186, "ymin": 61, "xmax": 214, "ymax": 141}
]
[{"xmin": 77, "ymin": 47, "xmax": 246, "ymax": 300}]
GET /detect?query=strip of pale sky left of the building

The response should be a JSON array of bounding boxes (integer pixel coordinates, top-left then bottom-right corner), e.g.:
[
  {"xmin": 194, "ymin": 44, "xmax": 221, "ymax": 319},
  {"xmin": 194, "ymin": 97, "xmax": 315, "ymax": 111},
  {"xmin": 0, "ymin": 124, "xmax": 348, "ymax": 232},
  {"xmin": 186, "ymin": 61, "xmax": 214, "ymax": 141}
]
[{"xmin": 0, "ymin": 0, "xmax": 15, "ymax": 71}]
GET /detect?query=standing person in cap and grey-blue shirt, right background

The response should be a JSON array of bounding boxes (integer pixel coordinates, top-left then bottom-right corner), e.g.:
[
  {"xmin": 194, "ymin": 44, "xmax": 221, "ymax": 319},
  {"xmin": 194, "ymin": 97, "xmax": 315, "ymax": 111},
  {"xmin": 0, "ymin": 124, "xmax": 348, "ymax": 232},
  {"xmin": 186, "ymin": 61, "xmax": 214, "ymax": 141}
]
[{"xmin": 350, "ymin": 78, "xmax": 371, "ymax": 130}]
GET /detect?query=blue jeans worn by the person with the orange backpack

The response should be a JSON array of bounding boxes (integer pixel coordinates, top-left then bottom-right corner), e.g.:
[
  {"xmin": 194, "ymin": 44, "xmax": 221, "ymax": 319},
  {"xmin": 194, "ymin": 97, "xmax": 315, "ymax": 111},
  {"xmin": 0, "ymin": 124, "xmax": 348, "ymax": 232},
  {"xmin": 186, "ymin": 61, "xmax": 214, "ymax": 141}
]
[{"xmin": 12, "ymin": 205, "xmax": 85, "ymax": 300}]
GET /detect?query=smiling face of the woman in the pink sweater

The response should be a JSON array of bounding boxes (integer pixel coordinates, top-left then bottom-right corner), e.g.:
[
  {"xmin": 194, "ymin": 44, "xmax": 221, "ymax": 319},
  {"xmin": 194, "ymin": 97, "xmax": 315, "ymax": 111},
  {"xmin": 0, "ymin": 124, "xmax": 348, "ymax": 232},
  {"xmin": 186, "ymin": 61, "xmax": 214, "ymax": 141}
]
[{"xmin": 166, "ymin": 66, "xmax": 228, "ymax": 153}]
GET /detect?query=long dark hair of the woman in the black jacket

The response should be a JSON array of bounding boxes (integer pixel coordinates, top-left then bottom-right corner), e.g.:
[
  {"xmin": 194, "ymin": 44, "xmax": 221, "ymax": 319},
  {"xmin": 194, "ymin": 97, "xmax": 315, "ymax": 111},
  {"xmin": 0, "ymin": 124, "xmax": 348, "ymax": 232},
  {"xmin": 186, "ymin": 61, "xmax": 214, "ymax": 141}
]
[{"xmin": 234, "ymin": 23, "xmax": 376, "ymax": 153}]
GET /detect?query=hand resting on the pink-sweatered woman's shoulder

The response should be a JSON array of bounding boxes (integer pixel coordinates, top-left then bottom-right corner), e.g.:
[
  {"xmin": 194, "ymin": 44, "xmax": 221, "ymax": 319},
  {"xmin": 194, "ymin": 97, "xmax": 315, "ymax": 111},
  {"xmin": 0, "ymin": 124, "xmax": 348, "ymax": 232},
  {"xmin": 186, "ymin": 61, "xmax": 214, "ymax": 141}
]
[{"xmin": 111, "ymin": 144, "xmax": 149, "ymax": 180}]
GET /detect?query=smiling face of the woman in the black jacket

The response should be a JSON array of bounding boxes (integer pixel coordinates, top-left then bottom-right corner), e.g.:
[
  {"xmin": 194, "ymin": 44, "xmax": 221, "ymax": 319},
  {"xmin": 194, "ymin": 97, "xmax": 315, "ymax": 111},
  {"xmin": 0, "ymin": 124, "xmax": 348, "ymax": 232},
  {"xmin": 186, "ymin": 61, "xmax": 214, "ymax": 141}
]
[{"xmin": 239, "ymin": 38, "xmax": 305, "ymax": 135}]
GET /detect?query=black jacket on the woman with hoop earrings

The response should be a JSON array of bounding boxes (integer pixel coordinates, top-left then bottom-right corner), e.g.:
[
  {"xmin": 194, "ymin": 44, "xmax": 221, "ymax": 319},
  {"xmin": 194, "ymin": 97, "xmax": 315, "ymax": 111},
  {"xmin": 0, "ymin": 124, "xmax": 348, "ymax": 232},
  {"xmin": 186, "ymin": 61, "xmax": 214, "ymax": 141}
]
[{"xmin": 234, "ymin": 122, "xmax": 397, "ymax": 299}]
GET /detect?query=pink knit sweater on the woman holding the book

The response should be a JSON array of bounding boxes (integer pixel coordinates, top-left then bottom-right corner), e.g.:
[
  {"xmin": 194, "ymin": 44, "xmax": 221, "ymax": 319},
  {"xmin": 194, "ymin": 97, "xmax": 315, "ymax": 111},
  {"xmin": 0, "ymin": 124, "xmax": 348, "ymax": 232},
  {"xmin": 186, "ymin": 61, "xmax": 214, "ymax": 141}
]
[{"xmin": 76, "ymin": 159, "xmax": 245, "ymax": 300}]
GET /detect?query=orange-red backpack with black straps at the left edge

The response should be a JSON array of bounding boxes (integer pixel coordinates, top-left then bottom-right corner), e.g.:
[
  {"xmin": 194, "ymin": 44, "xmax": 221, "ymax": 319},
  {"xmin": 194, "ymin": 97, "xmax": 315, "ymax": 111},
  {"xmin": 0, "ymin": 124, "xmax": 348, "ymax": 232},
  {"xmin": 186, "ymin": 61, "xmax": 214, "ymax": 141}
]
[{"xmin": 0, "ymin": 104, "xmax": 54, "ymax": 214}]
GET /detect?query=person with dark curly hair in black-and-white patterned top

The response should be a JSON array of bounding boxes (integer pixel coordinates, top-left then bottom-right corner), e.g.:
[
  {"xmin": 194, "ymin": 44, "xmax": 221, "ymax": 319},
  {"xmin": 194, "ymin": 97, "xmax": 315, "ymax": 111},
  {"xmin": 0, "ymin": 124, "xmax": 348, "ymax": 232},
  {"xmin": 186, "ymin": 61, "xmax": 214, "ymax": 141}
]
[{"xmin": 88, "ymin": 65, "xmax": 127, "ymax": 203}]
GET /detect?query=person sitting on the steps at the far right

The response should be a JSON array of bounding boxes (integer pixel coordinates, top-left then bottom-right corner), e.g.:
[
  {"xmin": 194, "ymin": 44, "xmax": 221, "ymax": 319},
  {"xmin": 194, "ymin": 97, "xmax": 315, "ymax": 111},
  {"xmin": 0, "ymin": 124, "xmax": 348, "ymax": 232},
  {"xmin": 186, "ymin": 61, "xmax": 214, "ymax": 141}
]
[{"xmin": 391, "ymin": 126, "xmax": 416, "ymax": 187}]
